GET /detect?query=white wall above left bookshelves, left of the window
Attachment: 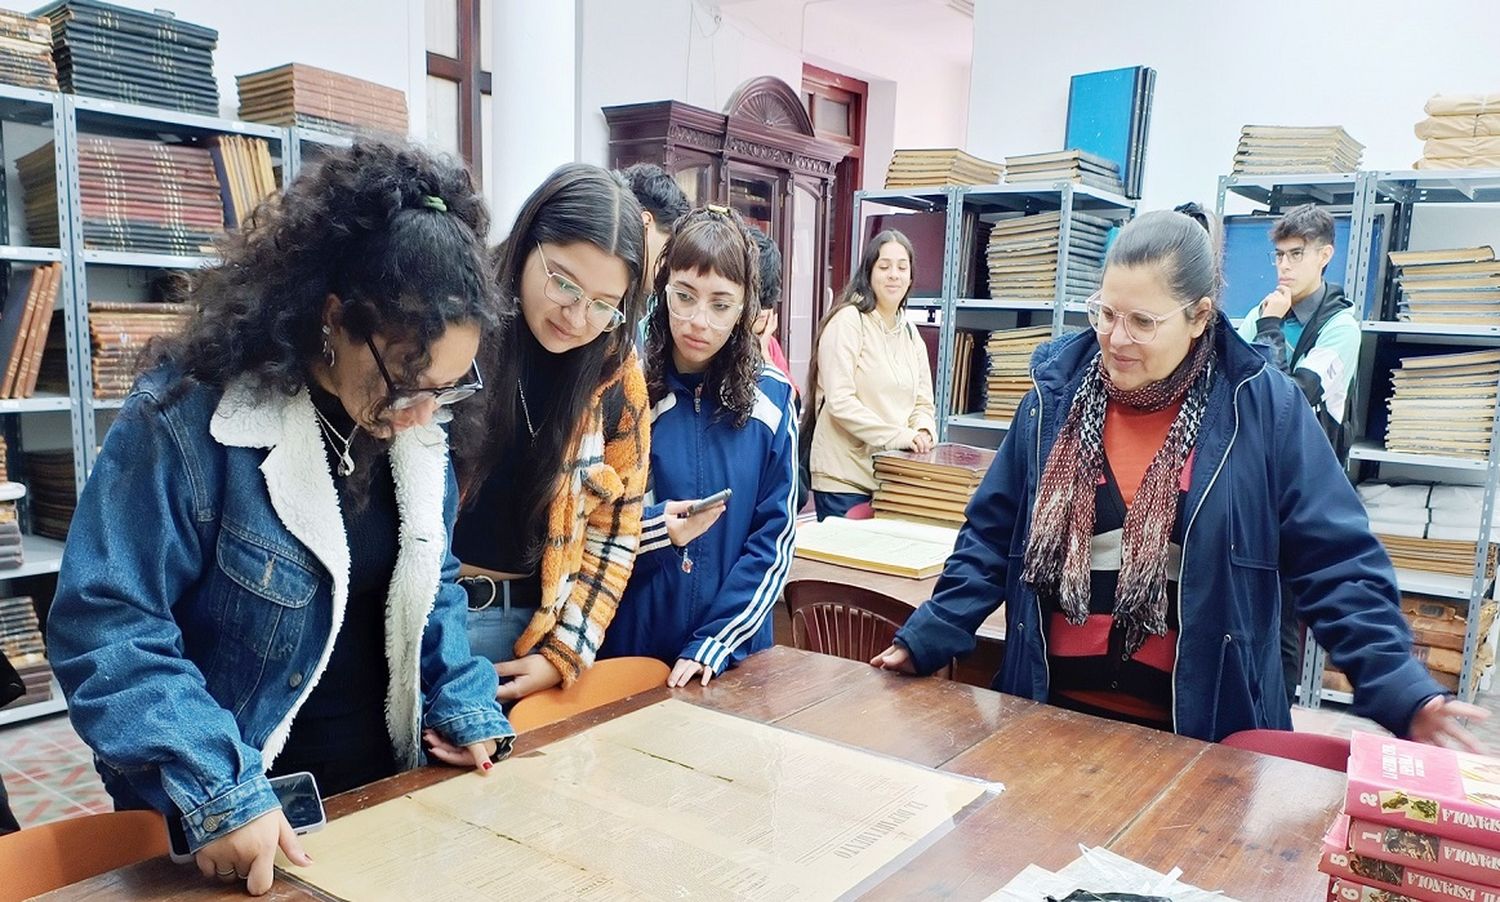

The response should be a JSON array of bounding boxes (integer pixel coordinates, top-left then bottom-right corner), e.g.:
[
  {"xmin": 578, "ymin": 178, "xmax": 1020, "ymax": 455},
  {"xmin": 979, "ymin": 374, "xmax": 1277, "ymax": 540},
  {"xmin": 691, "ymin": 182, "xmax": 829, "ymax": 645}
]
[{"xmin": 0, "ymin": 0, "xmax": 426, "ymax": 127}]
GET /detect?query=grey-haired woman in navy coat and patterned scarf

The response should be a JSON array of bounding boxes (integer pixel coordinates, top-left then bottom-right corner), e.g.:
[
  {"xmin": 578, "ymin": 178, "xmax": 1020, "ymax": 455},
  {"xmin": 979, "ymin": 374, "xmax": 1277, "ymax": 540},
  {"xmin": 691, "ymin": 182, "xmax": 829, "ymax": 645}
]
[{"xmin": 872, "ymin": 212, "xmax": 1485, "ymax": 747}]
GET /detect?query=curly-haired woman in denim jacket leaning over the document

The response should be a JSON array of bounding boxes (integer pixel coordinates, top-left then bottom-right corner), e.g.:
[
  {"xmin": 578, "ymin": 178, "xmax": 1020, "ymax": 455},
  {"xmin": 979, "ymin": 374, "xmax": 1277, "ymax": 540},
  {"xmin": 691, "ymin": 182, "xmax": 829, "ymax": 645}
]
[{"xmin": 48, "ymin": 144, "xmax": 513, "ymax": 894}]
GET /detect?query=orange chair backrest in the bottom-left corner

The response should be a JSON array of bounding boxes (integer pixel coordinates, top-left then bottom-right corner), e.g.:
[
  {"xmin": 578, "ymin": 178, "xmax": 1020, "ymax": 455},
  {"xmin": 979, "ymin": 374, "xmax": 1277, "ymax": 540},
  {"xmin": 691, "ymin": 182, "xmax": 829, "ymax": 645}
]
[{"xmin": 0, "ymin": 810, "xmax": 167, "ymax": 902}]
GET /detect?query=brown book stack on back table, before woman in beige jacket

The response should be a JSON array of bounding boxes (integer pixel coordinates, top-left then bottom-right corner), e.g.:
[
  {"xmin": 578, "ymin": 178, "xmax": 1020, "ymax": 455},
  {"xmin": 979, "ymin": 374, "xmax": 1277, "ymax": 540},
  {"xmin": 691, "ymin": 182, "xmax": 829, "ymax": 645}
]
[{"xmin": 875, "ymin": 443, "xmax": 995, "ymax": 527}]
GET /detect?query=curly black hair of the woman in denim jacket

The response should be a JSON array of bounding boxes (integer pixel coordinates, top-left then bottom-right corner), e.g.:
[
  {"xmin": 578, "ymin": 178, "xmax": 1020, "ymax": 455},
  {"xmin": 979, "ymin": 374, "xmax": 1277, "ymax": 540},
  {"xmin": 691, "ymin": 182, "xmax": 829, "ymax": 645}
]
[{"xmin": 149, "ymin": 141, "xmax": 494, "ymax": 470}]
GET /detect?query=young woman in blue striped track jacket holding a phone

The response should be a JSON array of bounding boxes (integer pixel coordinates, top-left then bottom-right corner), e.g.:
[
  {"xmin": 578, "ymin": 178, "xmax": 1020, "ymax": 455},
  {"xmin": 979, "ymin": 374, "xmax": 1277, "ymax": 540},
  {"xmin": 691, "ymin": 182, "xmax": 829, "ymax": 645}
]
[{"xmin": 600, "ymin": 207, "xmax": 797, "ymax": 686}]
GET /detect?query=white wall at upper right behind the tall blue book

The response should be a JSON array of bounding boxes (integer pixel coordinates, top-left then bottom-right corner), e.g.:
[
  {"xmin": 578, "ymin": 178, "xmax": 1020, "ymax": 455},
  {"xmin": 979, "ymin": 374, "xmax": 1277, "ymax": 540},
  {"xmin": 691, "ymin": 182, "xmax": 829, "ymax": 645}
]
[{"xmin": 969, "ymin": 0, "xmax": 1500, "ymax": 214}]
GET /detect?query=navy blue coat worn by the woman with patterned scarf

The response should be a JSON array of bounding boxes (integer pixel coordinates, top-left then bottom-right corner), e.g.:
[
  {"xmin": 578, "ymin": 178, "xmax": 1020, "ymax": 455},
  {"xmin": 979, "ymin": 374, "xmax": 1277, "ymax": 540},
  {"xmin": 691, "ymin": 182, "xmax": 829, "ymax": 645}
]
[{"xmin": 896, "ymin": 317, "xmax": 1443, "ymax": 741}]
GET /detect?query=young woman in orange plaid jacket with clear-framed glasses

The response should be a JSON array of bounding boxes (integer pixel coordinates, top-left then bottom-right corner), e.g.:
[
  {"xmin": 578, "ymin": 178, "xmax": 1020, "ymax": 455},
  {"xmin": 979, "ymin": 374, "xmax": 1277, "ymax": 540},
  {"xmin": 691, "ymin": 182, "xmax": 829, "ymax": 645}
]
[{"xmin": 453, "ymin": 164, "xmax": 650, "ymax": 702}]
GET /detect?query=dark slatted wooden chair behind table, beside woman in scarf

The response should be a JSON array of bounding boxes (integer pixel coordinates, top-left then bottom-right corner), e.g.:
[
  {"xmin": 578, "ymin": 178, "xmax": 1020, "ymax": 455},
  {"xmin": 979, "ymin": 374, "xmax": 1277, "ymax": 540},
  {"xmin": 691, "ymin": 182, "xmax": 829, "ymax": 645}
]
[{"xmin": 786, "ymin": 579, "xmax": 954, "ymax": 680}]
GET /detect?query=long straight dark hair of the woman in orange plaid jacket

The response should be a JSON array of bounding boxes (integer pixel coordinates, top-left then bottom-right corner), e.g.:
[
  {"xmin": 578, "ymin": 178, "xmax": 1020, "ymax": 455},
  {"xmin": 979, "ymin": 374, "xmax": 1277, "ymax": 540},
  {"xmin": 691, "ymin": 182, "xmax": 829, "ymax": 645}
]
[{"xmin": 459, "ymin": 164, "xmax": 647, "ymax": 549}]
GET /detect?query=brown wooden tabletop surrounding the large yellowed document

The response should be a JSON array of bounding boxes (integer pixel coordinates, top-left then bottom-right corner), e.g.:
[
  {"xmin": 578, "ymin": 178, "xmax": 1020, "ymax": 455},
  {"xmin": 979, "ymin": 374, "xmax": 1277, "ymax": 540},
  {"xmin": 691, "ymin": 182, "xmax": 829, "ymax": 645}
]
[{"xmin": 50, "ymin": 647, "xmax": 1344, "ymax": 902}]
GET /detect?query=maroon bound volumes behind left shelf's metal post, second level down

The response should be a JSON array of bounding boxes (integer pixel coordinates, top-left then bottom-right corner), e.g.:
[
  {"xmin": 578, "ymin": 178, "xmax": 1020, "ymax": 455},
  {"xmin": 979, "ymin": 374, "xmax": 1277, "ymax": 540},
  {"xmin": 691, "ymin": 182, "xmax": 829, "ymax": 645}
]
[{"xmin": 17, "ymin": 135, "xmax": 224, "ymax": 255}]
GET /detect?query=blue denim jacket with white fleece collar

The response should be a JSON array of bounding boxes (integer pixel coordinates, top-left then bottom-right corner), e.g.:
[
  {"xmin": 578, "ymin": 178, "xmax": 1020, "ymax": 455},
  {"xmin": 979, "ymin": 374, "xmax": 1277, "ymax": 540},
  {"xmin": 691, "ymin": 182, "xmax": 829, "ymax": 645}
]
[{"xmin": 48, "ymin": 361, "xmax": 513, "ymax": 849}]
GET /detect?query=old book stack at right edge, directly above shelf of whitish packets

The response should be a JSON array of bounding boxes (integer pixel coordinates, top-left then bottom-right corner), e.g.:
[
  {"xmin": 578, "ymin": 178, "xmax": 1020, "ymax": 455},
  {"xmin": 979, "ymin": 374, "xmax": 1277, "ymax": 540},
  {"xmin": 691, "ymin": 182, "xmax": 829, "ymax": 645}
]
[{"xmin": 1386, "ymin": 345, "xmax": 1500, "ymax": 461}]
